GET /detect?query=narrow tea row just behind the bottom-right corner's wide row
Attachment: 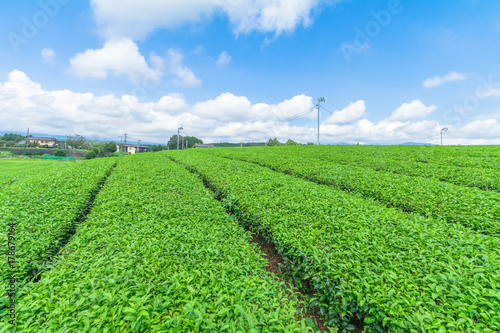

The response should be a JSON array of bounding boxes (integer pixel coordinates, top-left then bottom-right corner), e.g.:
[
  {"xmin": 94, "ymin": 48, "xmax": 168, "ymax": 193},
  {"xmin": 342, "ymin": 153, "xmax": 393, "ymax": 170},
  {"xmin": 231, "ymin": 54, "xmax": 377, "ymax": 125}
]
[{"xmin": 203, "ymin": 147, "xmax": 500, "ymax": 235}]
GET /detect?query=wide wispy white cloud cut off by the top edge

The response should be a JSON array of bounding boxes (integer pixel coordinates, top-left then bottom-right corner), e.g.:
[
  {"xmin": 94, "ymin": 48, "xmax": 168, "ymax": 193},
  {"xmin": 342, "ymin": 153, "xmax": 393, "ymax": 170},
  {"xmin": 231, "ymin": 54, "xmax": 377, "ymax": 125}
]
[{"xmin": 91, "ymin": 0, "xmax": 331, "ymax": 39}]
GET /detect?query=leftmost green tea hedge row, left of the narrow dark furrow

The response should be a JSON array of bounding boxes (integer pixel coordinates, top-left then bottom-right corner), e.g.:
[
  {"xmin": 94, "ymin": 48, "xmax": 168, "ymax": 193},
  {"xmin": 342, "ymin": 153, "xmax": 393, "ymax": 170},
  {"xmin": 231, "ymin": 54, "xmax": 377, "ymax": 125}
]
[{"xmin": 0, "ymin": 160, "xmax": 115, "ymax": 288}]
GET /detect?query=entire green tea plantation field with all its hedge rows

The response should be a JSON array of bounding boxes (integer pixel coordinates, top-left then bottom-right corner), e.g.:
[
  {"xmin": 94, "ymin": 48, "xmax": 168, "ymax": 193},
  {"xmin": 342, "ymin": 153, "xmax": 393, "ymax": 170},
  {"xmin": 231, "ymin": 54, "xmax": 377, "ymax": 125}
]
[{"xmin": 0, "ymin": 146, "xmax": 500, "ymax": 332}]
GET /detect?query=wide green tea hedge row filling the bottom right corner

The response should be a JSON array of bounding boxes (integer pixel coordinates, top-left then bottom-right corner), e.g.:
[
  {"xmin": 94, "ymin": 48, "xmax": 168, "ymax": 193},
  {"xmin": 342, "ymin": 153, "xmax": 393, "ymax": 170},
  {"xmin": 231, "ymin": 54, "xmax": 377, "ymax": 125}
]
[{"xmin": 169, "ymin": 151, "xmax": 500, "ymax": 332}]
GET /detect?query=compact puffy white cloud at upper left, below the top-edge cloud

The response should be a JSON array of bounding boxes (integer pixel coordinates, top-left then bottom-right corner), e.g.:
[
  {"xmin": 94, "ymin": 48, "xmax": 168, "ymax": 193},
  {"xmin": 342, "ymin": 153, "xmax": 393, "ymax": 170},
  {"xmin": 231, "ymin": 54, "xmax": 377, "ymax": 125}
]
[{"xmin": 70, "ymin": 38, "xmax": 161, "ymax": 84}]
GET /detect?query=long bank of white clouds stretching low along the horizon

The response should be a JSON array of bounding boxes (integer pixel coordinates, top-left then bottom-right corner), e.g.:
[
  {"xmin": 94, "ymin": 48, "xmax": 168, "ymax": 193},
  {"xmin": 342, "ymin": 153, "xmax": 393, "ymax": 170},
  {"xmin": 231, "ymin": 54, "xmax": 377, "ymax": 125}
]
[{"xmin": 0, "ymin": 70, "xmax": 500, "ymax": 144}]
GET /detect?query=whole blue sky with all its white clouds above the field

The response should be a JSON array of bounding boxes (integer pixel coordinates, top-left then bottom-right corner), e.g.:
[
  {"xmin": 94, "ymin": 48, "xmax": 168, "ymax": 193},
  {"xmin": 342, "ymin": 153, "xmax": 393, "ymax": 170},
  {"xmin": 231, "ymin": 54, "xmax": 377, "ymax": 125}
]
[{"xmin": 0, "ymin": 0, "xmax": 500, "ymax": 144}]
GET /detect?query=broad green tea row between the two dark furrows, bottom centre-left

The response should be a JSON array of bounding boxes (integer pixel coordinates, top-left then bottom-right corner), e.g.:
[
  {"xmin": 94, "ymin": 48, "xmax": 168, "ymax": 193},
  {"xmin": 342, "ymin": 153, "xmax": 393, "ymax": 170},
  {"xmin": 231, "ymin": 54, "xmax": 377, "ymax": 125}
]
[{"xmin": 7, "ymin": 154, "xmax": 312, "ymax": 332}]
